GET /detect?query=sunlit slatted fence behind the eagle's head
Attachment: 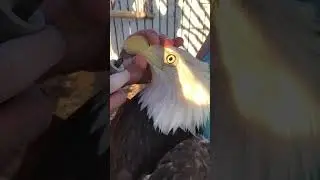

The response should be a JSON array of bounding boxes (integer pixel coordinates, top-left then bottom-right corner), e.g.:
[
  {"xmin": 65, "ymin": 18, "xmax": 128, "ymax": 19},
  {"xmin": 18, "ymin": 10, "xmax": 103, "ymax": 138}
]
[{"xmin": 110, "ymin": 0, "xmax": 211, "ymax": 59}]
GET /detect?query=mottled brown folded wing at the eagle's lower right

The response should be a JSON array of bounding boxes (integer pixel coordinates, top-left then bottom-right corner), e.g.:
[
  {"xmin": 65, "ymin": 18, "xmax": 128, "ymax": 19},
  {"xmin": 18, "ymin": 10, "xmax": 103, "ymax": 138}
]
[{"xmin": 148, "ymin": 137, "xmax": 212, "ymax": 180}]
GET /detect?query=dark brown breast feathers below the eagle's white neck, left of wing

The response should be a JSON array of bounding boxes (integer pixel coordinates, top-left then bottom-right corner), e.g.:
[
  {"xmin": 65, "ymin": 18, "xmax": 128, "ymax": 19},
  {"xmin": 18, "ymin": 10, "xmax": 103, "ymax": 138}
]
[{"xmin": 110, "ymin": 94, "xmax": 192, "ymax": 180}]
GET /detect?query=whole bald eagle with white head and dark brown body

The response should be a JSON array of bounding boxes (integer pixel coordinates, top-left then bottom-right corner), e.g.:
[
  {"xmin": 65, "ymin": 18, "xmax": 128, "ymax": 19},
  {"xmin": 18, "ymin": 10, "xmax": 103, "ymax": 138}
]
[{"xmin": 110, "ymin": 36, "xmax": 210, "ymax": 180}]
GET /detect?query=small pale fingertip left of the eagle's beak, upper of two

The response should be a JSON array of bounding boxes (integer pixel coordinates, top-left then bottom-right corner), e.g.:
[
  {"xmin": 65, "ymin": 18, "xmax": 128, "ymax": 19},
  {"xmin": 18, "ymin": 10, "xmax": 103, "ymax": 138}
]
[{"xmin": 110, "ymin": 70, "xmax": 130, "ymax": 94}]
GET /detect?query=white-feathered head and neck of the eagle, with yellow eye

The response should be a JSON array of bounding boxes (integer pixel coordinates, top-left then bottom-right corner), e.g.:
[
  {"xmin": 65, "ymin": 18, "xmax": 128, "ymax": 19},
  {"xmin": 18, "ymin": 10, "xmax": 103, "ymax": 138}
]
[{"xmin": 122, "ymin": 35, "xmax": 210, "ymax": 134}]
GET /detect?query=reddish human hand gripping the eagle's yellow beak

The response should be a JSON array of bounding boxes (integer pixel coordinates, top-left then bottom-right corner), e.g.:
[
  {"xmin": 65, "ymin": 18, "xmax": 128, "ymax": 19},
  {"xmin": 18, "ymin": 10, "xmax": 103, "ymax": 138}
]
[{"xmin": 121, "ymin": 29, "xmax": 183, "ymax": 84}]
